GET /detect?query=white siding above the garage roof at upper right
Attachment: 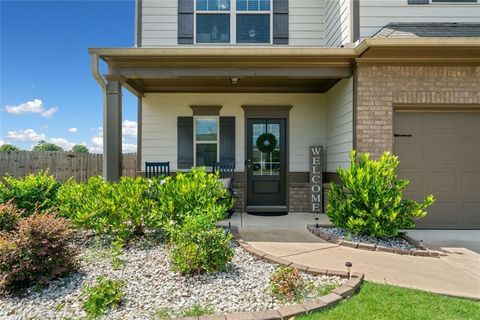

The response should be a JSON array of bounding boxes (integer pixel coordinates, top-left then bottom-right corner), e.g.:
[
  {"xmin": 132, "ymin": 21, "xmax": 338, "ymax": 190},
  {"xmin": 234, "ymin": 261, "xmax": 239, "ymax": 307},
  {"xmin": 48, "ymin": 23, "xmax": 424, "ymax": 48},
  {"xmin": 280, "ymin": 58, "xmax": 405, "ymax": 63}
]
[{"xmin": 360, "ymin": 0, "xmax": 480, "ymax": 38}]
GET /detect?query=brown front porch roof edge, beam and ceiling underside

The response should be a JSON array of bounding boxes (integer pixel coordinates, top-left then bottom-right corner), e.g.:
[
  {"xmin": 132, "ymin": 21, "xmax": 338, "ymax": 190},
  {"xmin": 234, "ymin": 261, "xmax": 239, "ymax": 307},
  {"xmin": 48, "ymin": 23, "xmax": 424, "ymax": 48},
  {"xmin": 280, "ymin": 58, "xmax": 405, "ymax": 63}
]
[{"xmin": 89, "ymin": 47, "xmax": 356, "ymax": 95}]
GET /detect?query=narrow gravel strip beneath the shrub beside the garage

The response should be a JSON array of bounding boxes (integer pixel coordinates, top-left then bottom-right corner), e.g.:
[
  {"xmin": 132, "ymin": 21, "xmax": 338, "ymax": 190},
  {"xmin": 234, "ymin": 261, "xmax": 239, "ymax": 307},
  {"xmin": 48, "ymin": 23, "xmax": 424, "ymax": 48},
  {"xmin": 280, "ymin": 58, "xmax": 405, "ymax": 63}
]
[{"xmin": 317, "ymin": 227, "xmax": 420, "ymax": 250}]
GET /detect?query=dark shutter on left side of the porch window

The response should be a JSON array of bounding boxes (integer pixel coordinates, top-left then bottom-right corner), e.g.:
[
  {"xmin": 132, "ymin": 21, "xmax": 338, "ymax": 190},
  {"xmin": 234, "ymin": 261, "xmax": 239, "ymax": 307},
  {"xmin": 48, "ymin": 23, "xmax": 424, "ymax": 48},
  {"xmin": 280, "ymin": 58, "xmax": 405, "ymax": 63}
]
[{"xmin": 177, "ymin": 117, "xmax": 193, "ymax": 169}]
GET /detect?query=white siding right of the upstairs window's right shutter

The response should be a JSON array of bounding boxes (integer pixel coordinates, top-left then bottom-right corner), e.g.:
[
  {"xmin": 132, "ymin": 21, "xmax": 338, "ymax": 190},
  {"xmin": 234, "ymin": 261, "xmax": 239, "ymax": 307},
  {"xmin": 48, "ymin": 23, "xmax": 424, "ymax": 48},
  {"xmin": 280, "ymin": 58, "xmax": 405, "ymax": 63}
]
[{"xmin": 288, "ymin": 0, "xmax": 325, "ymax": 46}]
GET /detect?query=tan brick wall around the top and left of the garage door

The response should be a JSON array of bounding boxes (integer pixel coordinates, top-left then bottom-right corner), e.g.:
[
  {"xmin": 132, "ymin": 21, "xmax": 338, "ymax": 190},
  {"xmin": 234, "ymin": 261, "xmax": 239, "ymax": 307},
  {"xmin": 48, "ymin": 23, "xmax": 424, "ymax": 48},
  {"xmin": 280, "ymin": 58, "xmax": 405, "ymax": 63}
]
[{"xmin": 355, "ymin": 64, "xmax": 480, "ymax": 158}]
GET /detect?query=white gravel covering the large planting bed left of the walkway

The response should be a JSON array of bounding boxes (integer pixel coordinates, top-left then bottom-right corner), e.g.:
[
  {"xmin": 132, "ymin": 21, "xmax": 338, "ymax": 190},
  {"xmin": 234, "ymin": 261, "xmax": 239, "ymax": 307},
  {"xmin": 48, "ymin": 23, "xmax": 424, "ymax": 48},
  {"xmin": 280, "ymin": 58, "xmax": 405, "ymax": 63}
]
[{"xmin": 0, "ymin": 240, "xmax": 344, "ymax": 320}]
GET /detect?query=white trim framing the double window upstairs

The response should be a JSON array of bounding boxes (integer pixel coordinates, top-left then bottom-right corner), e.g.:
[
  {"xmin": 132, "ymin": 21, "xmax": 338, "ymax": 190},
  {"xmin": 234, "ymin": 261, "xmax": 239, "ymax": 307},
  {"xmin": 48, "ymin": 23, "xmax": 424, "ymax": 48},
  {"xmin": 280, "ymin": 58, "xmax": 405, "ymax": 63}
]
[{"xmin": 193, "ymin": 0, "xmax": 273, "ymax": 46}]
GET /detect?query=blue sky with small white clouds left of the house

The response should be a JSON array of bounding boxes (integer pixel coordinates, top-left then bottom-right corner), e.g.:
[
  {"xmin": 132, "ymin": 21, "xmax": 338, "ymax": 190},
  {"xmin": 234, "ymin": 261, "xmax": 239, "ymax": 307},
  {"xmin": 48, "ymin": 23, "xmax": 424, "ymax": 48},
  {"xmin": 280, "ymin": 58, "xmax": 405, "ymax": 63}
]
[{"xmin": 0, "ymin": 0, "xmax": 137, "ymax": 152}]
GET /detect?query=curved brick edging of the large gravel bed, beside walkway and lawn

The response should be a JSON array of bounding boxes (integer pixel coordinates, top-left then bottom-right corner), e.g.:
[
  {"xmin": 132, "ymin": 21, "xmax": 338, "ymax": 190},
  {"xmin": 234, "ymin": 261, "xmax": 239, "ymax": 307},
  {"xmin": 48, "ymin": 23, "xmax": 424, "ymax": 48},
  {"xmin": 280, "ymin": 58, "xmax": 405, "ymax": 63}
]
[{"xmin": 179, "ymin": 227, "xmax": 364, "ymax": 320}]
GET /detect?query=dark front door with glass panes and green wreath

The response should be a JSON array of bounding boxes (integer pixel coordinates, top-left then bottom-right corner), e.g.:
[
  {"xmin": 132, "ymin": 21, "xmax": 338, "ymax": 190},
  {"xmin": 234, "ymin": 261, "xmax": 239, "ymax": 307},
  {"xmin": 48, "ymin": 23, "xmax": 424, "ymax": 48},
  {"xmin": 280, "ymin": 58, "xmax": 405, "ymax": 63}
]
[{"xmin": 246, "ymin": 118, "xmax": 287, "ymax": 213}]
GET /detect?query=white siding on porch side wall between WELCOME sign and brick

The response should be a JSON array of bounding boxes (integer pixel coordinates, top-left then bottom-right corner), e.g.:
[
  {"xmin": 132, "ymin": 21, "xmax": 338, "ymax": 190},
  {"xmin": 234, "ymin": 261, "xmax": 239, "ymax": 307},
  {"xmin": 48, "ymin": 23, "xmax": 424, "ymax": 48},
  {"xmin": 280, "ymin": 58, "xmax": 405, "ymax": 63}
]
[{"xmin": 326, "ymin": 78, "xmax": 353, "ymax": 172}]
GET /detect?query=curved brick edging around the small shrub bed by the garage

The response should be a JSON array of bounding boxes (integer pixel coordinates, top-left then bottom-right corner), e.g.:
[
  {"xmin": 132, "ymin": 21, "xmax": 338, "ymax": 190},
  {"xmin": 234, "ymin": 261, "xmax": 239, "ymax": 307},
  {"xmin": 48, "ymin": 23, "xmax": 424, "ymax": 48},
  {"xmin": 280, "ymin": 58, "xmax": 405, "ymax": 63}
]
[{"xmin": 307, "ymin": 224, "xmax": 442, "ymax": 258}]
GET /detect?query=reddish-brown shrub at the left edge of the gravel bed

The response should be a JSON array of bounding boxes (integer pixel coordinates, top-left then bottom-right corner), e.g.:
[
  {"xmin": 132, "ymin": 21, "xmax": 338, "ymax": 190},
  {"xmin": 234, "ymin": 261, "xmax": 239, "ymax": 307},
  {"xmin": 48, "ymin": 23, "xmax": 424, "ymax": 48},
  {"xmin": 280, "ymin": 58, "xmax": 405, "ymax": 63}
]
[{"xmin": 0, "ymin": 214, "xmax": 77, "ymax": 291}]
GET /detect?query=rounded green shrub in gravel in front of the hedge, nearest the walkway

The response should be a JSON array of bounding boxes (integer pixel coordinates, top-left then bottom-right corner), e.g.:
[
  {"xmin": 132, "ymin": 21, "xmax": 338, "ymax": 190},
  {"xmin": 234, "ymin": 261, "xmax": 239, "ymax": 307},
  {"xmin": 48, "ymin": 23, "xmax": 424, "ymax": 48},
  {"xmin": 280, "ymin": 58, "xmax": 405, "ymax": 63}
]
[{"xmin": 170, "ymin": 214, "xmax": 234, "ymax": 274}]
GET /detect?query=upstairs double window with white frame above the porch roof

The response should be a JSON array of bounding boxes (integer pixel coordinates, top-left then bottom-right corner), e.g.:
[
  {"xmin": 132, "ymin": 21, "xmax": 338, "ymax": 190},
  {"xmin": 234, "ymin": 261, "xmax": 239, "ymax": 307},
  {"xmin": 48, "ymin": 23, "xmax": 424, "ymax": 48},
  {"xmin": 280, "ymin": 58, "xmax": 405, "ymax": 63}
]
[{"xmin": 195, "ymin": 0, "xmax": 272, "ymax": 44}]
